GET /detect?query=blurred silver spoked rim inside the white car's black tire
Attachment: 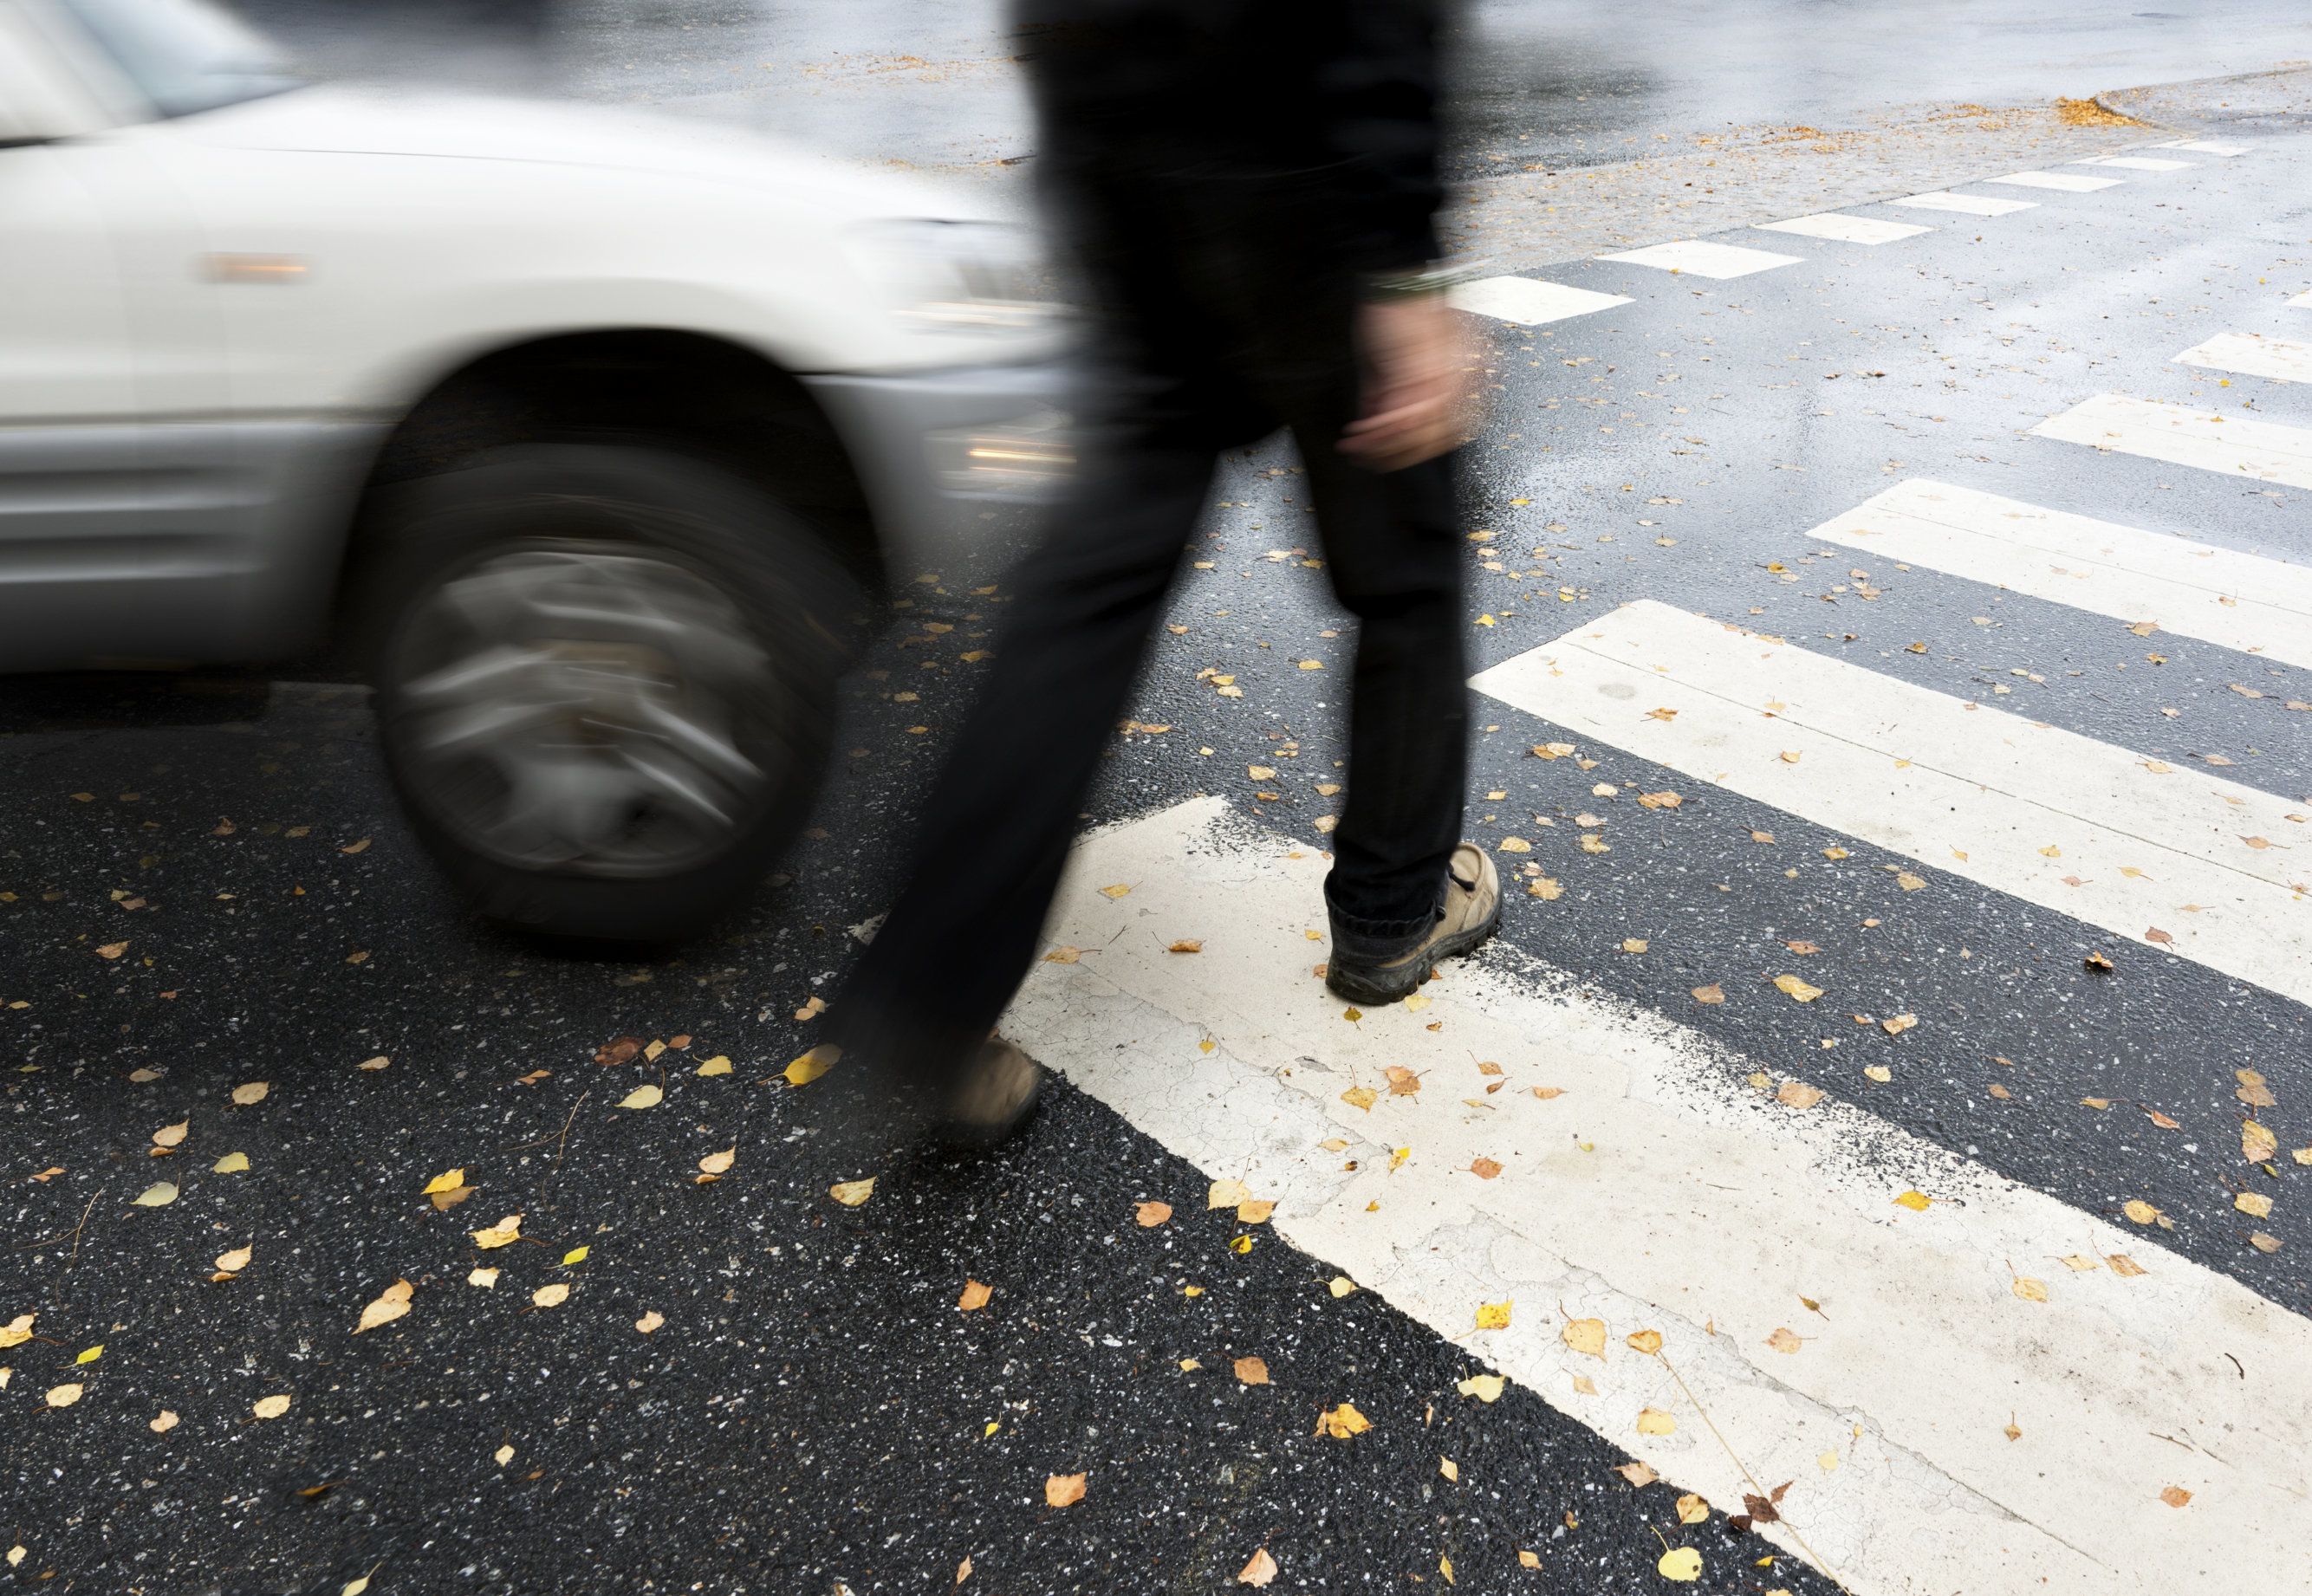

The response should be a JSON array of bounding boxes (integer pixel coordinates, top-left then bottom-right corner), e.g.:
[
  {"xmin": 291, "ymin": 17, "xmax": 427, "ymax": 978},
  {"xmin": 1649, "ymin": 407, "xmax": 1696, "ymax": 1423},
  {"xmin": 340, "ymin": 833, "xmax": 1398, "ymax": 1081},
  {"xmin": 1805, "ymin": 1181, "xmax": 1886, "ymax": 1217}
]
[{"xmin": 388, "ymin": 543, "xmax": 783, "ymax": 877}]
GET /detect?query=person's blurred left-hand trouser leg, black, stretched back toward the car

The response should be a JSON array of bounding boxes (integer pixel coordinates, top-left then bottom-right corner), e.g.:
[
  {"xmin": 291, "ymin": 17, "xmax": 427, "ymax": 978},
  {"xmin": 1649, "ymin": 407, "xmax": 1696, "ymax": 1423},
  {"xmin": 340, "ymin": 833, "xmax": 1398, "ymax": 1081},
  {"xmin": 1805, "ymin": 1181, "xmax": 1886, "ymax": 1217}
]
[{"xmin": 830, "ymin": 425, "xmax": 1216, "ymax": 1108}]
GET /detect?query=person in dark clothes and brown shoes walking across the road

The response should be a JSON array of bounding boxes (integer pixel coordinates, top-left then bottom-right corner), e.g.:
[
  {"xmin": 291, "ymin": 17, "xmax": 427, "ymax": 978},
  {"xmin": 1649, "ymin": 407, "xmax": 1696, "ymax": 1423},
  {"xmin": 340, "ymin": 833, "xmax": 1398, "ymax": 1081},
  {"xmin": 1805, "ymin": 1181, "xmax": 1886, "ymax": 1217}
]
[{"xmin": 830, "ymin": 0, "xmax": 1501, "ymax": 1143}]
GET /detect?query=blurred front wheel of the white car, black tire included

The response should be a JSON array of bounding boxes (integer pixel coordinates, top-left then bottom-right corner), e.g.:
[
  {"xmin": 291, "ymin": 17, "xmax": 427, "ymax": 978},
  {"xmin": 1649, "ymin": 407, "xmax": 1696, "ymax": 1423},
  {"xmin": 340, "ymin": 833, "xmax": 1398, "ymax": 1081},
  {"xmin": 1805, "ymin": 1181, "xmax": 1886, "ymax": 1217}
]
[{"xmin": 366, "ymin": 442, "xmax": 855, "ymax": 944}]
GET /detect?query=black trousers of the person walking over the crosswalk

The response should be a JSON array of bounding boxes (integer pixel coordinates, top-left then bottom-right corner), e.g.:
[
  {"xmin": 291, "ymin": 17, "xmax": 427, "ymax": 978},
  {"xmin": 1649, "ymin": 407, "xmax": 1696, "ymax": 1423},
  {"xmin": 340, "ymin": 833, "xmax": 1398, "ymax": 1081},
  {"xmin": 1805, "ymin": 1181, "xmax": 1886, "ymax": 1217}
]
[{"xmin": 828, "ymin": 227, "xmax": 1468, "ymax": 1082}]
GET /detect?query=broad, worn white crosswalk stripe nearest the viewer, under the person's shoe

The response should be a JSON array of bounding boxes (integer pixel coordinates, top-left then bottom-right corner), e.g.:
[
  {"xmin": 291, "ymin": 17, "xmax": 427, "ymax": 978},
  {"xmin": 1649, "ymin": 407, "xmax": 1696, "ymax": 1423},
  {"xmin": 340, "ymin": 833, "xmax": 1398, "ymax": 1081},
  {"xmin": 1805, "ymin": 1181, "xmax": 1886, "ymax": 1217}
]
[{"xmin": 1022, "ymin": 798, "xmax": 2312, "ymax": 1596}]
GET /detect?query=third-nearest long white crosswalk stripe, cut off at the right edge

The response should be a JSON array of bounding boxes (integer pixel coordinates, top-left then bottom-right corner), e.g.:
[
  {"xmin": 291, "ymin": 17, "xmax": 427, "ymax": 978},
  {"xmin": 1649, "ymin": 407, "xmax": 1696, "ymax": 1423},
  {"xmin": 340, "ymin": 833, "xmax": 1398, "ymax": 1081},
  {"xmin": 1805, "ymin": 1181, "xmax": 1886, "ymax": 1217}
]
[{"xmin": 1806, "ymin": 481, "xmax": 2312, "ymax": 665}]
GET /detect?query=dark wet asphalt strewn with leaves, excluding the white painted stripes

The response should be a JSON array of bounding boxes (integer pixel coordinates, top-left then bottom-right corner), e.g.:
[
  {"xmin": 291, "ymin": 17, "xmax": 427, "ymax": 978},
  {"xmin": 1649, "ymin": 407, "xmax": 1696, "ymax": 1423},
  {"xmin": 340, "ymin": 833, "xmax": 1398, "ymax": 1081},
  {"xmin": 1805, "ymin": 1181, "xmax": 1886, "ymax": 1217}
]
[{"xmin": 13, "ymin": 10, "xmax": 2312, "ymax": 1596}]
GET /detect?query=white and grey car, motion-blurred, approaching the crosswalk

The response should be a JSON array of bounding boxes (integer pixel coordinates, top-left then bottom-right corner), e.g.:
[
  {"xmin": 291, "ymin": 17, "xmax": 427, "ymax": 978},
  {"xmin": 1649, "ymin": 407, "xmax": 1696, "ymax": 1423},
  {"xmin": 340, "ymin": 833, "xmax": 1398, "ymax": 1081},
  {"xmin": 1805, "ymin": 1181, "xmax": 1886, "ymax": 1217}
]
[{"xmin": 0, "ymin": 0, "xmax": 1068, "ymax": 939}]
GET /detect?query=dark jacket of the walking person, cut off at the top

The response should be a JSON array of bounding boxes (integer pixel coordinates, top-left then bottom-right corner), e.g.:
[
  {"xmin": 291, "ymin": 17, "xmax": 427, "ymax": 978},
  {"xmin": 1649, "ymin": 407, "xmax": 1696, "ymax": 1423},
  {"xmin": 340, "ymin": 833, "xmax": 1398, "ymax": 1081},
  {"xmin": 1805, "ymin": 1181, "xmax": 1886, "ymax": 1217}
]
[{"xmin": 1015, "ymin": 0, "xmax": 1450, "ymax": 270}]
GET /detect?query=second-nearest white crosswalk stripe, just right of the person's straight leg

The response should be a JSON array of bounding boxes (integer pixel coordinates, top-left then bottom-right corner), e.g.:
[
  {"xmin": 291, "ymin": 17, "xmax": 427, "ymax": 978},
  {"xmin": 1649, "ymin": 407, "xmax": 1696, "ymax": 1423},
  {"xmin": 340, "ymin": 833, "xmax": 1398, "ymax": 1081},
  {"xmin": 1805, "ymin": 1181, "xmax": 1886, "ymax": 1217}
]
[{"xmin": 1473, "ymin": 599, "xmax": 2312, "ymax": 1004}]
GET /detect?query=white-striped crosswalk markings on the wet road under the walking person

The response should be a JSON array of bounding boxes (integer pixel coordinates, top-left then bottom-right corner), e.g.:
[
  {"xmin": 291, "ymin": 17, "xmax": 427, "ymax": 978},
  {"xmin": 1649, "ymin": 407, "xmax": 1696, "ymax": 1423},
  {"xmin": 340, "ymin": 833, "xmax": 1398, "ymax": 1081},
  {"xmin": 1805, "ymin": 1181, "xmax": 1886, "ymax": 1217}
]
[{"xmin": 1006, "ymin": 127, "xmax": 2312, "ymax": 1596}]
